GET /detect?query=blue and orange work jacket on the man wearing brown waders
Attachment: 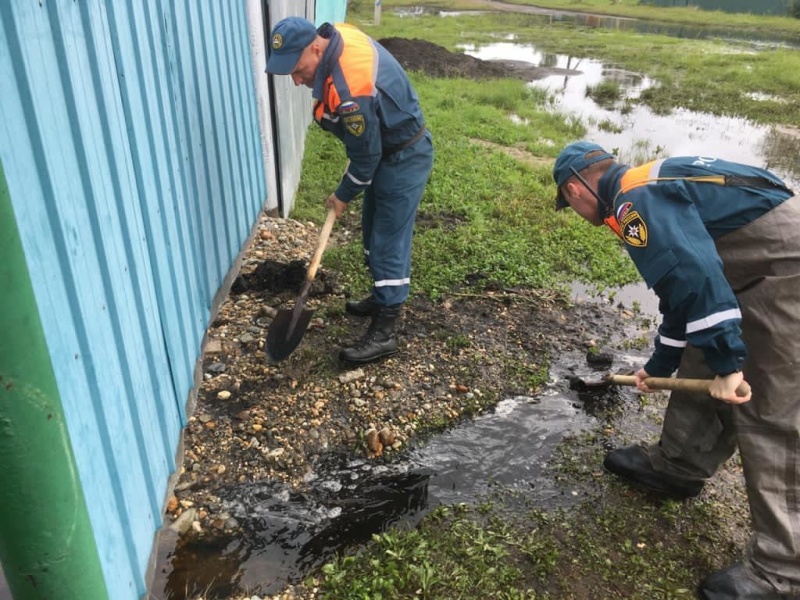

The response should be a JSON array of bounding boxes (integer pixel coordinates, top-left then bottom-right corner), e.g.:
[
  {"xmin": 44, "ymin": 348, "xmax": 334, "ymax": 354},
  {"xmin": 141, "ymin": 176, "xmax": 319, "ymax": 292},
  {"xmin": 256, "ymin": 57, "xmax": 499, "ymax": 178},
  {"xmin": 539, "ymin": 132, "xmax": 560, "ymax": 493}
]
[{"xmin": 598, "ymin": 156, "xmax": 792, "ymax": 376}]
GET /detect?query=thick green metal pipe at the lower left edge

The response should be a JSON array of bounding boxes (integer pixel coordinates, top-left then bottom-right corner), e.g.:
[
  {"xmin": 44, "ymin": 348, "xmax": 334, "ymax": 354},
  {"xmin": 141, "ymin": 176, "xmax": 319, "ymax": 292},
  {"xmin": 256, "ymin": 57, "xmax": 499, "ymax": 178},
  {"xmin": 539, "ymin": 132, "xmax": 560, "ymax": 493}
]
[{"xmin": 0, "ymin": 164, "xmax": 108, "ymax": 600}]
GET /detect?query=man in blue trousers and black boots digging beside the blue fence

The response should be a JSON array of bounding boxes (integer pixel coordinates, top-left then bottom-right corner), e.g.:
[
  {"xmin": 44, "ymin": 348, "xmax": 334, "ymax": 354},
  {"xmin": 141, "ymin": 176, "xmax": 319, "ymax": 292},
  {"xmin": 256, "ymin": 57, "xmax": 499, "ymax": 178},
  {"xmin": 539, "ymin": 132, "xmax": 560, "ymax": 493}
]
[{"xmin": 267, "ymin": 17, "xmax": 433, "ymax": 363}]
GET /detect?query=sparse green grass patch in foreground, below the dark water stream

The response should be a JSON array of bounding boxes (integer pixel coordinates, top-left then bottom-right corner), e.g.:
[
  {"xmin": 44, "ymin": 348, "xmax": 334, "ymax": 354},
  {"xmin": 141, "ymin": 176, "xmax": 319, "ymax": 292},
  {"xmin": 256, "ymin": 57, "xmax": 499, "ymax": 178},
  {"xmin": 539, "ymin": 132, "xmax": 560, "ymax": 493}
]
[{"xmin": 307, "ymin": 483, "xmax": 737, "ymax": 600}]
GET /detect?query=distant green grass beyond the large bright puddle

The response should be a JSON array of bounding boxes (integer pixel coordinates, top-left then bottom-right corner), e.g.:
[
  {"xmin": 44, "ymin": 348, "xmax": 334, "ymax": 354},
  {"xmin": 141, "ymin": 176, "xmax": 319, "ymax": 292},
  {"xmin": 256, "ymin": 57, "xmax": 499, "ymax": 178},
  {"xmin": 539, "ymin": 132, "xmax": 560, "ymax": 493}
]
[{"xmin": 353, "ymin": 0, "xmax": 800, "ymax": 124}]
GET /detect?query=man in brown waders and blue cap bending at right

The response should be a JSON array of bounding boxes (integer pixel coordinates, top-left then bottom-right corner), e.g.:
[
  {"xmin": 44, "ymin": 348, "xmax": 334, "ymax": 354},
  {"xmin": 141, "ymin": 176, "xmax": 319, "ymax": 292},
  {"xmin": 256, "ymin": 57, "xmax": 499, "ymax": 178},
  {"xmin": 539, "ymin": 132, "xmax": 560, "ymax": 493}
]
[{"xmin": 553, "ymin": 142, "xmax": 800, "ymax": 600}]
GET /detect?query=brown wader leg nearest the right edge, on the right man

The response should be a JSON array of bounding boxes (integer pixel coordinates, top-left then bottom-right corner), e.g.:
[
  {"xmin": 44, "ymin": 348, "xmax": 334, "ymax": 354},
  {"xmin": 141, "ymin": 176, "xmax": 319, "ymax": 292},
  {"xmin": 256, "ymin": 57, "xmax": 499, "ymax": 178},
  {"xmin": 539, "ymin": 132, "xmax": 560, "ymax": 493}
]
[{"xmin": 717, "ymin": 196, "xmax": 800, "ymax": 594}]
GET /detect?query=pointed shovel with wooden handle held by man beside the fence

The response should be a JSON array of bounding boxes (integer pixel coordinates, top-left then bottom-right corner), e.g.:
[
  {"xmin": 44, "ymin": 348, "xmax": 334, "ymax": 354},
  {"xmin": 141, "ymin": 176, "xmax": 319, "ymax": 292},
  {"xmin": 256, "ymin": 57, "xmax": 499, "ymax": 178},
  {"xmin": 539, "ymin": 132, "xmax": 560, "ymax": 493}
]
[{"xmin": 267, "ymin": 209, "xmax": 336, "ymax": 363}]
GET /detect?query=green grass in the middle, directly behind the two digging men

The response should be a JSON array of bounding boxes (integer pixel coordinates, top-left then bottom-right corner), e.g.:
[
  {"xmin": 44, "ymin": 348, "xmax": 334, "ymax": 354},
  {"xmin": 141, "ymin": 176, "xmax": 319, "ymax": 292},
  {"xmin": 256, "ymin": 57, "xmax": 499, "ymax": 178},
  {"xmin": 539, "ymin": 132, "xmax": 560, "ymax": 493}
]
[{"xmin": 295, "ymin": 74, "xmax": 637, "ymax": 298}]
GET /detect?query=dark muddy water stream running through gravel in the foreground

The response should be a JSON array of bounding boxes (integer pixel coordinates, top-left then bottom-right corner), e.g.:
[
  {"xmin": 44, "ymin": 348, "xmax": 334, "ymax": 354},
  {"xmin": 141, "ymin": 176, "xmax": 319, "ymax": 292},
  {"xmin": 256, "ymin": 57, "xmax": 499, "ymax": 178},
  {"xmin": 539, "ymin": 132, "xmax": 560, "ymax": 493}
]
[{"xmin": 152, "ymin": 340, "xmax": 642, "ymax": 600}]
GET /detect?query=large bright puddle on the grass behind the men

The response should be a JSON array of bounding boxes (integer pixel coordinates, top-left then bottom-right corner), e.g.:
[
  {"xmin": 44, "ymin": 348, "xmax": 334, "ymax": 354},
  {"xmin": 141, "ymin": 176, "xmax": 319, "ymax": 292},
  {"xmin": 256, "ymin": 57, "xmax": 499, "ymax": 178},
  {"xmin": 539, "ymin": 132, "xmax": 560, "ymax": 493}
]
[{"xmin": 462, "ymin": 42, "xmax": 800, "ymax": 189}]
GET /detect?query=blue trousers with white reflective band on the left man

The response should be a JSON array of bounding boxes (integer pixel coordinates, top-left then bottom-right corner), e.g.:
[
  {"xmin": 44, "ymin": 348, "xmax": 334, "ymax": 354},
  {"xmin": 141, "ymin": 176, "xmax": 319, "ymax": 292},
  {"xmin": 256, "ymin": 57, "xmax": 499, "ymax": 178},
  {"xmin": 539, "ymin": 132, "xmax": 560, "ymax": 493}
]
[{"xmin": 365, "ymin": 134, "xmax": 433, "ymax": 306}]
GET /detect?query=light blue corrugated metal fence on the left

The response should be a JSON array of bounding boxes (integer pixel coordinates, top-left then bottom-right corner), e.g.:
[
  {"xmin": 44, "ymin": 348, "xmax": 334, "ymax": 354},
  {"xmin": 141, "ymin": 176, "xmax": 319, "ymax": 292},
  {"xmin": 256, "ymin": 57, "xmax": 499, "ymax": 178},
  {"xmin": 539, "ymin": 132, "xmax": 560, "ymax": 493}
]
[{"xmin": 0, "ymin": 0, "xmax": 265, "ymax": 598}]
